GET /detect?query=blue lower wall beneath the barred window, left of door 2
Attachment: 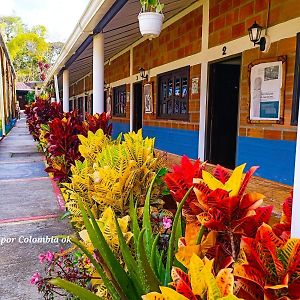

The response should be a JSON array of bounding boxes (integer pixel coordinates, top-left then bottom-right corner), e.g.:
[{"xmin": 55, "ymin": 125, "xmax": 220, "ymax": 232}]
[{"xmin": 143, "ymin": 126, "xmax": 199, "ymax": 158}]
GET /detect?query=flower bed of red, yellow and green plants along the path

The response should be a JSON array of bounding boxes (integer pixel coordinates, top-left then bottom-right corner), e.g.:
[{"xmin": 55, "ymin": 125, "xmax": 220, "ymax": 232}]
[{"xmin": 24, "ymin": 96, "xmax": 300, "ymax": 300}]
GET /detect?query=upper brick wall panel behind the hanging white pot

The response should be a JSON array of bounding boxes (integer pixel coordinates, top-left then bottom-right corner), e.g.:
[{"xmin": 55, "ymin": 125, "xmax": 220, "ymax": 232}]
[{"xmin": 133, "ymin": 7, "xmax": 202, "ymax": 74}]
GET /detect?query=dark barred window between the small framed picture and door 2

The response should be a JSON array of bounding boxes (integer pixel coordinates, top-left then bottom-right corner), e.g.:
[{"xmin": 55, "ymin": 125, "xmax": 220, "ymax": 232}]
[{"xmin": 157, "ymin": 67, "xmax": 190, "ymax": 120}]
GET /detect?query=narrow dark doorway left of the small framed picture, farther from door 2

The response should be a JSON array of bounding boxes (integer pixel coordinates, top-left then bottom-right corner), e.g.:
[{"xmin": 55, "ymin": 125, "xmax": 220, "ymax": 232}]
[{"xmin": 133, "ymin": 82, "xmax": 143, "ymax": 132}]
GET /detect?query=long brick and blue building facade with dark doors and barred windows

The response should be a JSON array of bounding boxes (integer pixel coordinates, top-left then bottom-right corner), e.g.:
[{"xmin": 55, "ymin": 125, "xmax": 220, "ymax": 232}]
[{"xmin": 47, "ymin": 0, "xmax": 300, "ymax": 185}]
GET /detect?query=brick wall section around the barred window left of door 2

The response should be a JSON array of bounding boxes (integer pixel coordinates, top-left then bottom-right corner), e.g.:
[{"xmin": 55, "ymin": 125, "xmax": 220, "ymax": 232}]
[{"xmin": 143, "ymin": 65, "xmax": 201, "ymax": 130}]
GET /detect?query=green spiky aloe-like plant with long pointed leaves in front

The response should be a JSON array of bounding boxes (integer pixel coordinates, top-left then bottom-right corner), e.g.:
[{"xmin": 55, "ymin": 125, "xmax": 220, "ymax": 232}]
[{"xmin": 51, "ymin": 178, "xmax": 191, "ymax": 300}]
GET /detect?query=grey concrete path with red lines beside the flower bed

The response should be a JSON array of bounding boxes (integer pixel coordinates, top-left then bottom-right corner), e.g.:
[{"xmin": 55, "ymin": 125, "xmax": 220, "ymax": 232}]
[{"xmin": 0, "ymin": 113, "xmax": 71, "ymax": 300}]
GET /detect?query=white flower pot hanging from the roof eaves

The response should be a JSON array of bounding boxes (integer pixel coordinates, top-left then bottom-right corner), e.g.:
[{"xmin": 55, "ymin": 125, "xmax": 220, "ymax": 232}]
[{"xmin": 138, "ymin": 12, "xmax": 164, "ymax": 39}]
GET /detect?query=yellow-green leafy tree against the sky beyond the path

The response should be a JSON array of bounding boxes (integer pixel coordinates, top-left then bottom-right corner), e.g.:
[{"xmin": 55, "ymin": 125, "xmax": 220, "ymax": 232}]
[{"xmin": 0, "ymin": 16, "xmax": 63, "ymax": 82}]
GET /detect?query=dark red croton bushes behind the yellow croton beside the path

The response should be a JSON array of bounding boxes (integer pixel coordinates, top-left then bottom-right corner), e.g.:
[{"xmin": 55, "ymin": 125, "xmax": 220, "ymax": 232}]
[{"xmin": 25, "ymin": 97, "xmax": 112, "ymax": 182}]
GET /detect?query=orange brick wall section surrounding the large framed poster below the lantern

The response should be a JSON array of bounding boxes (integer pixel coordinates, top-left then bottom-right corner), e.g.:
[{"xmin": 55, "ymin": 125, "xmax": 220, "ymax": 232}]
[{"xmin": 239, "ymin": 37, "xmax": 297, "ymax": 141}]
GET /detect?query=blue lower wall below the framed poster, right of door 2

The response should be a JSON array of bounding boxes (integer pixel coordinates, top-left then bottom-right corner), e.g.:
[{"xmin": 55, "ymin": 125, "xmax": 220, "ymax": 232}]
[{"xmin": 237, "ymin": 137, "xmax": 296, "ymax": 185}]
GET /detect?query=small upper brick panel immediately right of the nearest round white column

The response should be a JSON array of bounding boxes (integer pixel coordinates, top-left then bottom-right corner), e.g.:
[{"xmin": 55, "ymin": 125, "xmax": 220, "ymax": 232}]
[{"xmin": 104, "ymin": 51, "xmax": 130, "ymax": 83}]
